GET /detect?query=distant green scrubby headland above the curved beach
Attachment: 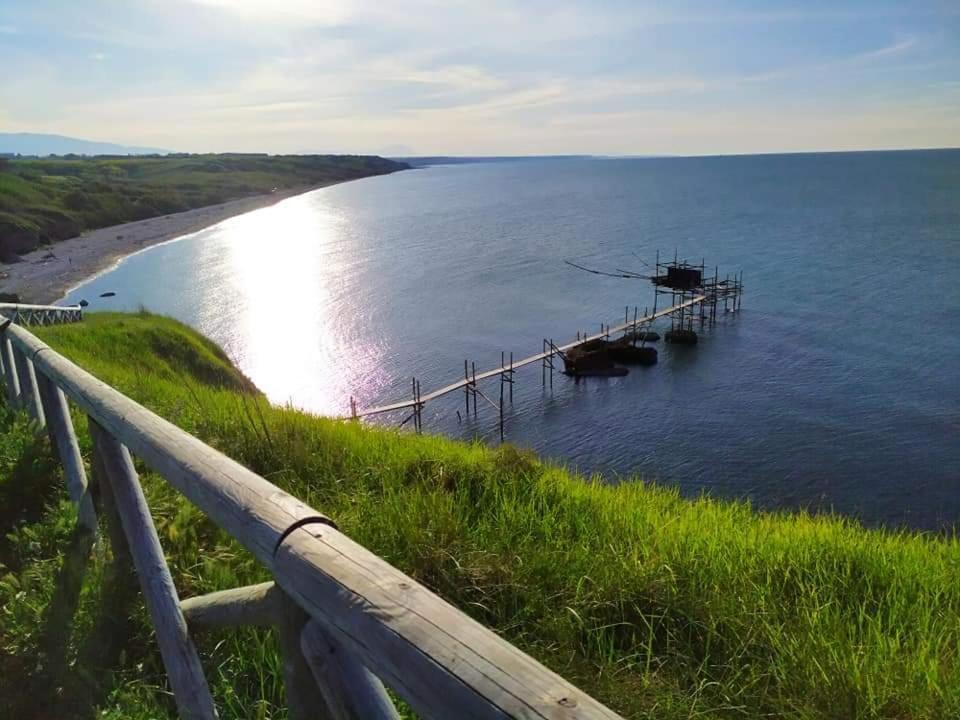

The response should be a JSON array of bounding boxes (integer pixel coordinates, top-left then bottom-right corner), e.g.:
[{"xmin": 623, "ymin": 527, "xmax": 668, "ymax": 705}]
[{"xmin": 0, "ymin": 154, "xmax": 406, "ymax": 260}]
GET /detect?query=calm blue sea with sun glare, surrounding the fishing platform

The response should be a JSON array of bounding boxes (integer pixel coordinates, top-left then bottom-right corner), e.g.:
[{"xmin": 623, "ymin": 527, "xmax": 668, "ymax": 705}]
[{"xmin": 66, "ymin": 151, "xmax": 960, "ymax": 529}]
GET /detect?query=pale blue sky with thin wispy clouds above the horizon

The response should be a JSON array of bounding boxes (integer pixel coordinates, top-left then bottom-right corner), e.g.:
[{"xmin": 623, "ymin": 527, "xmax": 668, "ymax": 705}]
[{"xmin": 0, "ymin": 0, "xmax": 960, "ymax": 155}]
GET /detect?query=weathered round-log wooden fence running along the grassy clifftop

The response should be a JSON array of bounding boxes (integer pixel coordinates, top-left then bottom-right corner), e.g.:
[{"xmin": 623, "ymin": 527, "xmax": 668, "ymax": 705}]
[{"xmin": 0, "ymin": 306, "xmax": 618, "ymax": 720}]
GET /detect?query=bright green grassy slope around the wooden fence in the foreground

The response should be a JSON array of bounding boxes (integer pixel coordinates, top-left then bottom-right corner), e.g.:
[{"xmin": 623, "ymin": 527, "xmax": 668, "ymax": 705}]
[{"xmin": 0, "ymin": 315, "xmax": 960, "ymax": 718}]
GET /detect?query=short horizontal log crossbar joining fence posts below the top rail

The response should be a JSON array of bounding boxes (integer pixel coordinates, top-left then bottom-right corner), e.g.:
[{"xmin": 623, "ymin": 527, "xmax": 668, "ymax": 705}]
[{"xmin": 180, "ymin": 582, "xmax": 282, "ymax": 628}]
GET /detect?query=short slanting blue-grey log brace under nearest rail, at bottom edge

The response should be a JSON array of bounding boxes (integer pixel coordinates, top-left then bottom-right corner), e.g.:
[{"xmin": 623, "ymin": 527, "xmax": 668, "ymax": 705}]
[{"xmin": 300, "ymin": 620, "xmax": 400, "ymax": 720}]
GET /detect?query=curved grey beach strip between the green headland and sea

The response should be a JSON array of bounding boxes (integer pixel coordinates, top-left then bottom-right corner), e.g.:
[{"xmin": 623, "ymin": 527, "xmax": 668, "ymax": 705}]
[{"xmin": 0, "ymin": 186, "xmax": 323, "ymax": 305}]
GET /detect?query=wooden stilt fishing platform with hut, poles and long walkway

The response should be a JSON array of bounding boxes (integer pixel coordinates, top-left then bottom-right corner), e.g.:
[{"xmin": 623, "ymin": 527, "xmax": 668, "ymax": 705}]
[{"xmin": 343, "ymin": 252, "xmax": 743, "ymax": 441}]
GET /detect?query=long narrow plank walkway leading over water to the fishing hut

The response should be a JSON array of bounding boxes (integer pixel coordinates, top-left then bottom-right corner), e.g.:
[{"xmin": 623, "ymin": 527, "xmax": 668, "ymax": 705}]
[{"xmin": 350, "ymin": 295, "xmax": 708, "ymax": 418}]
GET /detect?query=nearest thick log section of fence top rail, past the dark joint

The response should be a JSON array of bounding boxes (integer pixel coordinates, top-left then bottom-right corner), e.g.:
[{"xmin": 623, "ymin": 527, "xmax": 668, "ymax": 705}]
[{"xmin": 274, "ymin": 525, "xmax": 617, "ymax": 719}]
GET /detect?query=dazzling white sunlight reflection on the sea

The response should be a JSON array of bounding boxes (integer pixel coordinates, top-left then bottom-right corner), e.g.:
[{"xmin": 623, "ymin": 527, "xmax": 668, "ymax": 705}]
[{"xmin": 191, "ymin": 196, "xmax": 386, "ymax": 414}]
